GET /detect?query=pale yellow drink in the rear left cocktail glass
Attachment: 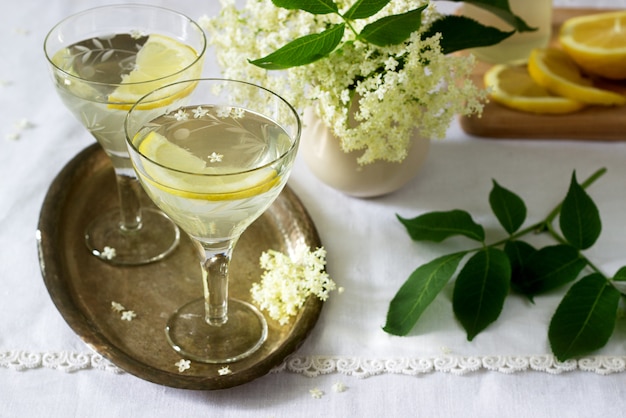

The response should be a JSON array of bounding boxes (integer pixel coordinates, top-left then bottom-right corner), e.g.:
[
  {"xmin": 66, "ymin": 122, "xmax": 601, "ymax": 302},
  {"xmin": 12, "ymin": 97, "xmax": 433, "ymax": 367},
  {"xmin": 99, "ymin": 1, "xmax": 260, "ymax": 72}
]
[{"xmin": 52, "ymin": 33, "xmax": 202, "ymax": 170}]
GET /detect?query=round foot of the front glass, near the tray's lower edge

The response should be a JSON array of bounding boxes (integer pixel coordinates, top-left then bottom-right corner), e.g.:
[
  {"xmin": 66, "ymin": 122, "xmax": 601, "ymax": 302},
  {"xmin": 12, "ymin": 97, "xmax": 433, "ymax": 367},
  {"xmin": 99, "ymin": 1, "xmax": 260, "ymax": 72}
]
[{"xmin": 165, "ymin": 299, "xmax": 267, "ymax": 363}]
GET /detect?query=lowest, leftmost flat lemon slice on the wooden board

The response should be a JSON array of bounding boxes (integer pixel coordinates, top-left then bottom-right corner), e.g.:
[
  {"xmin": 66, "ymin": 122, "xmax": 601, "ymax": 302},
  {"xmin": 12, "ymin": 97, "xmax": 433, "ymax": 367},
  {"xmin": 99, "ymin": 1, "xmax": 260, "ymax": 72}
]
[{"xmin": 484, "ymin": 64, "xmax": 585, "ymax": 114}]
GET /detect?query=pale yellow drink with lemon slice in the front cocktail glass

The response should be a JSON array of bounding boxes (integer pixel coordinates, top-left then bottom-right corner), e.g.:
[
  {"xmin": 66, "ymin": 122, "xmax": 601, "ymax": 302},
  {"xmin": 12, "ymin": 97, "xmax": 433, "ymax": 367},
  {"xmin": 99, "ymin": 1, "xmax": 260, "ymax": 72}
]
[{"xmin": 131, "ymin": 105, "xmax": 293, "ymax": 244}]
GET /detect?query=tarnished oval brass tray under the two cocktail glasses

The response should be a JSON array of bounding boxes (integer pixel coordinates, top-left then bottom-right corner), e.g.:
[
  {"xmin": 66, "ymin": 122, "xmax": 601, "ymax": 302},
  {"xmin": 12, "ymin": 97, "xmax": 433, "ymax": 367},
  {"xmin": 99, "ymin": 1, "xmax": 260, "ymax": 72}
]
[{"xmin": 38, "ymin": 144, "xmax": 322, "ymax": 390}]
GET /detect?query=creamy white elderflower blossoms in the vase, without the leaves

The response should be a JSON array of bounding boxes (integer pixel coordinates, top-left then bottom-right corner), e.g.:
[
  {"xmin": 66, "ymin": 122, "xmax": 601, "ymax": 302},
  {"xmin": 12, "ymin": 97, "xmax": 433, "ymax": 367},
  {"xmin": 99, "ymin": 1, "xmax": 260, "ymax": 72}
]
[{"xmin": 200, "ymin": 0, "xmax": 486, "ymax": 164}]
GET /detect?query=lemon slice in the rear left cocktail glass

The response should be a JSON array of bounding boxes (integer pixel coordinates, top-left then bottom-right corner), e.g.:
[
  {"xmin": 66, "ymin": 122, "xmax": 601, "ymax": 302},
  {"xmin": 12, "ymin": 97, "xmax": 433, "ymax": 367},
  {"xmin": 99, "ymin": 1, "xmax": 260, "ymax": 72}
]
[{"xmin": 108, "ymin": 34, "xmax": 202, "ymax": 110}]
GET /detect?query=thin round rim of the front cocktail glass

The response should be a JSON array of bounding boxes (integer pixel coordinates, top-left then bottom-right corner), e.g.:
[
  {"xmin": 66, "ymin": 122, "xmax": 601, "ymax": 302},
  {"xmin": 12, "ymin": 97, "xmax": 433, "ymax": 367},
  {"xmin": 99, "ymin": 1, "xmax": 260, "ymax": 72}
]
[{"xmin": 124, "ymin": 78, "xmax": 302, "ymax": 178}]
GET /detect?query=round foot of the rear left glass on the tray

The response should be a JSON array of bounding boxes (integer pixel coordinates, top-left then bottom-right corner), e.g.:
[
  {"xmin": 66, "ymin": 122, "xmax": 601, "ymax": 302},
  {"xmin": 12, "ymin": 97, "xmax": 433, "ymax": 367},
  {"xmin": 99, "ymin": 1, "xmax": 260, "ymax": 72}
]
[{"xmin": 85, "ymin": 208, "xmax": 180, "ymax": 265}]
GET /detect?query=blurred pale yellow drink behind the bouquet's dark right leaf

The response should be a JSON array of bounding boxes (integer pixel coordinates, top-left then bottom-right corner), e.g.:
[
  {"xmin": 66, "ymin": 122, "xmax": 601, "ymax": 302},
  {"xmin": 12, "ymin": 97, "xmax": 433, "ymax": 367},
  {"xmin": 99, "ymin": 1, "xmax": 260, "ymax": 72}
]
[{"xmin": 460, "ymin": 0, "xmax": 552, "ymax": 64}]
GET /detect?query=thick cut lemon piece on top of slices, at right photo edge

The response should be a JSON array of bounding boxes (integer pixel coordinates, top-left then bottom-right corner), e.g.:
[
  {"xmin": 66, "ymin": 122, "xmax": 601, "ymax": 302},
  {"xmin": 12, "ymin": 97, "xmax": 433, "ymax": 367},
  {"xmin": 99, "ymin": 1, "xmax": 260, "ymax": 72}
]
[{"xmin": 559, "ymin": 10, "xmax": 626, "ymax": 80}]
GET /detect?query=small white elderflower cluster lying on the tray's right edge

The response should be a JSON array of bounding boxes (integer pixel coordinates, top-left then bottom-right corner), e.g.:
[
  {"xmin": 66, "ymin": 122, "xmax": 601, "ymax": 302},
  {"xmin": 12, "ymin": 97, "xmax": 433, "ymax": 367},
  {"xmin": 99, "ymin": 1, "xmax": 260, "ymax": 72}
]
[{"xmin": 251, "ymin": 247, "xmax": 336, "ymax": 325}]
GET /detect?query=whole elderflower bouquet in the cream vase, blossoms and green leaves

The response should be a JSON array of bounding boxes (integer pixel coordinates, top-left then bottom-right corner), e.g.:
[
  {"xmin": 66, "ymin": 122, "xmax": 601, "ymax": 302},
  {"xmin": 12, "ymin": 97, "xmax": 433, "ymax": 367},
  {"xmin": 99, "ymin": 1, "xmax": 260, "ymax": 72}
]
[{"xmin": 200, "ymin": 0, "xmax": 529, "ymax": 164}]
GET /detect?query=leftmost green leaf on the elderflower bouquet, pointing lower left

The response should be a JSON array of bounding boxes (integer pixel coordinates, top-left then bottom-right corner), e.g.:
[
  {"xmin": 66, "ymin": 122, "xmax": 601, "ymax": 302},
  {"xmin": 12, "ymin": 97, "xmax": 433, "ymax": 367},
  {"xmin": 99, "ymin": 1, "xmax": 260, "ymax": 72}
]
[{"xmin": 250, "ymin": 23, "xmax": 345, "ymax": 70}]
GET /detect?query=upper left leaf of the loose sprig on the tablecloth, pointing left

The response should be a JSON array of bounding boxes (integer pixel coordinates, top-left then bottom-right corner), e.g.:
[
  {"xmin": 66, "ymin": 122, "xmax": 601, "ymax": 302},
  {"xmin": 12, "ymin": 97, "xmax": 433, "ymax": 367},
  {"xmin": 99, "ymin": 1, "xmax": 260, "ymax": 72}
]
[{"xmin": 396, "ymin": 209, "xmax": 485, "ymax": 242}]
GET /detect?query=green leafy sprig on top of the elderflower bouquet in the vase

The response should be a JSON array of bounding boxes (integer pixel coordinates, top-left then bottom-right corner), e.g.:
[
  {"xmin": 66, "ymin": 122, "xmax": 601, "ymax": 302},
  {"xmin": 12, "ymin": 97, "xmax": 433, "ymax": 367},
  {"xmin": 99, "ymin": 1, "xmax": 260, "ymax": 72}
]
[{"xmin": 249, "ymin": 0, "xmax": 535, "ymax": 70}]
